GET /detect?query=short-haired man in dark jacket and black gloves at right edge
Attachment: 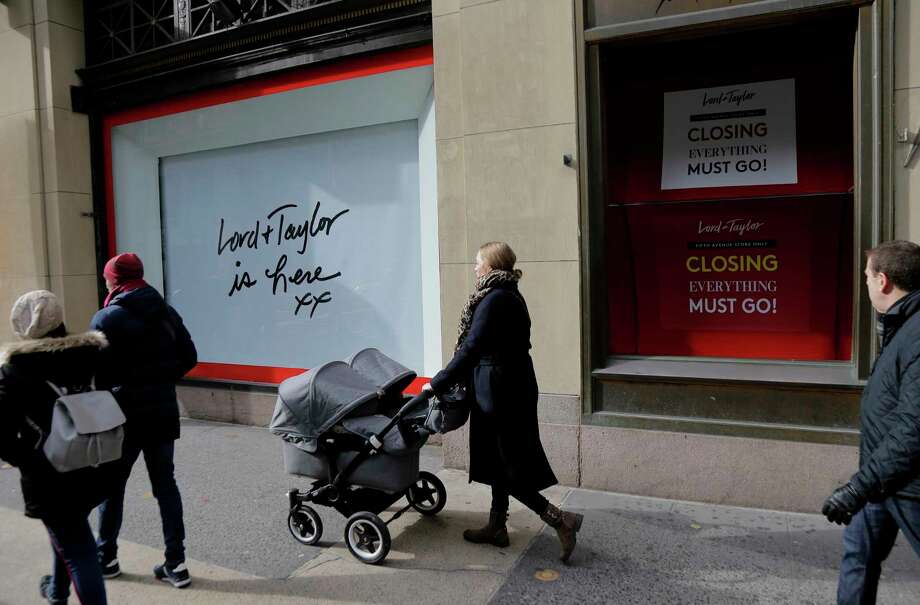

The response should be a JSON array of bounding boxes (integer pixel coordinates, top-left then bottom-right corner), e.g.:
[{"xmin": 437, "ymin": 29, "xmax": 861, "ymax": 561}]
[{"xmin": 822, "ymin": 241, "xmax": 920, "ymax": 603}]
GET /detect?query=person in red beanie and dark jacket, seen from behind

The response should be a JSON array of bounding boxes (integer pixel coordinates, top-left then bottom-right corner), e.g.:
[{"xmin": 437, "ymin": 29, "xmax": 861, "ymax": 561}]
[{"xmin": 91, "ymin": 253, "xmax": 197, "ymax": 588}]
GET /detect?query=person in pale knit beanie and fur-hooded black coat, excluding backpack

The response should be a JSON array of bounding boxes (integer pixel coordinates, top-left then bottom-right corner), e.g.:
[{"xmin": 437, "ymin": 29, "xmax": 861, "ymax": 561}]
[{"xmin": 0, "ymin": 290, "xmax": 114, "ymax": 605}]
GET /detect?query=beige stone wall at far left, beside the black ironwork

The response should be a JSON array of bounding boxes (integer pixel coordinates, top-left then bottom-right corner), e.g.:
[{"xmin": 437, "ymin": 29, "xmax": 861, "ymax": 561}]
[{"xmin": 0, "ymin": 0, "xmax": 97, "ymax": 341}]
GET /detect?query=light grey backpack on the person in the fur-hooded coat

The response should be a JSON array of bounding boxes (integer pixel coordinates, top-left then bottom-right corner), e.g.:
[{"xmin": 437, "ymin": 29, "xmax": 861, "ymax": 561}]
[{"xmin": 42, "ymin": 379, "xmax": 125, "ymax": 473}]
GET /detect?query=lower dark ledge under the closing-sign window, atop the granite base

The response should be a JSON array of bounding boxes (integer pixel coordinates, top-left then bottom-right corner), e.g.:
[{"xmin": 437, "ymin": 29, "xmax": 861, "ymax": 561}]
[{"xmin": 582, "ymin": 412, "xmax": 859, "ymax": 445}]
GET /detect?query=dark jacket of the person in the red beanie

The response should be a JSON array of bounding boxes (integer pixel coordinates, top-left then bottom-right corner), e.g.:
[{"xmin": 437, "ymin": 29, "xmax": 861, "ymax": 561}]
[{"xmin": 90, "ymin": 286, "xmax": 198, "ymax": 441}]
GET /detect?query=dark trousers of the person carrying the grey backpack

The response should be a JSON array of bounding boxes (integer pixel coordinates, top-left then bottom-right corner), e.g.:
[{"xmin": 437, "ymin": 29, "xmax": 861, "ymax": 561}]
[{"xmin": 43, "ymin": 516, "xmax": 106, "ymax": 605}]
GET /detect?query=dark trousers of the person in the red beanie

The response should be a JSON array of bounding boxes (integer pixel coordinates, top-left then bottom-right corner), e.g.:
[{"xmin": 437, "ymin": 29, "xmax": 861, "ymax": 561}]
[{"xmin": 97, "ymin": 438, "xmax": 185, "ymax": 567}]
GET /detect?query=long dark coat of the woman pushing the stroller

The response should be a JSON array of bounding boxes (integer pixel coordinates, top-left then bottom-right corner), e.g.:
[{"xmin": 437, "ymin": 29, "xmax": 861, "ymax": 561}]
[{"xmin": 431, "ymin": 286, "xmax": 557, "ymax": 491}]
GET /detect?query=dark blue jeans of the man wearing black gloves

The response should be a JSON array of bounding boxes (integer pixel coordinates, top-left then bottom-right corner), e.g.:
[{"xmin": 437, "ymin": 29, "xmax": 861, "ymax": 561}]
[{"xmin": 837, "ymin": 497, "xmax": 920, "ymax": 605}]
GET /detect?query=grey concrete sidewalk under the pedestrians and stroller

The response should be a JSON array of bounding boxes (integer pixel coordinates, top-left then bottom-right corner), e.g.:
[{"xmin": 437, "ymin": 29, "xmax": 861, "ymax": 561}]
[{"xmin": 0, "ymin": 421, "xmax": 920, "ymax": 605}]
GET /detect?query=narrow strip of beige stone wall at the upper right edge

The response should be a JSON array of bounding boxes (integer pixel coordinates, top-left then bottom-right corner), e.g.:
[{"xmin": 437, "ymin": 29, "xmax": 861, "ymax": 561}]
[{"xmin": 893, "ymin": 0, "xmax": 920, "ymax": 242}]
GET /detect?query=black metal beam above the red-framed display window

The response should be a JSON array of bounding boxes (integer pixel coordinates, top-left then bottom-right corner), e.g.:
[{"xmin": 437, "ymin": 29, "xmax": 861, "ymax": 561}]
[{"xmin": 77, "ymin": 0, "xmax": 431, "ymax": 111}]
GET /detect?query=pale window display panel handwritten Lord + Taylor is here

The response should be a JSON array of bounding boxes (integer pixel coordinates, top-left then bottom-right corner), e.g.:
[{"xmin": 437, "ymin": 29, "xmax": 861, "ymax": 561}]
[{"xmin": 111, "ymin": 66, "xmax": 441, "ymax": 375}]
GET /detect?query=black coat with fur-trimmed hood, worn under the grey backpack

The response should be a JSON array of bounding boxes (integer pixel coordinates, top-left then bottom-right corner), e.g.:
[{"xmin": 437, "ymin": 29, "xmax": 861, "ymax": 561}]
[{"xmin": 0, "ymin": 332, "xmax": 117, "ymax": 519}]
